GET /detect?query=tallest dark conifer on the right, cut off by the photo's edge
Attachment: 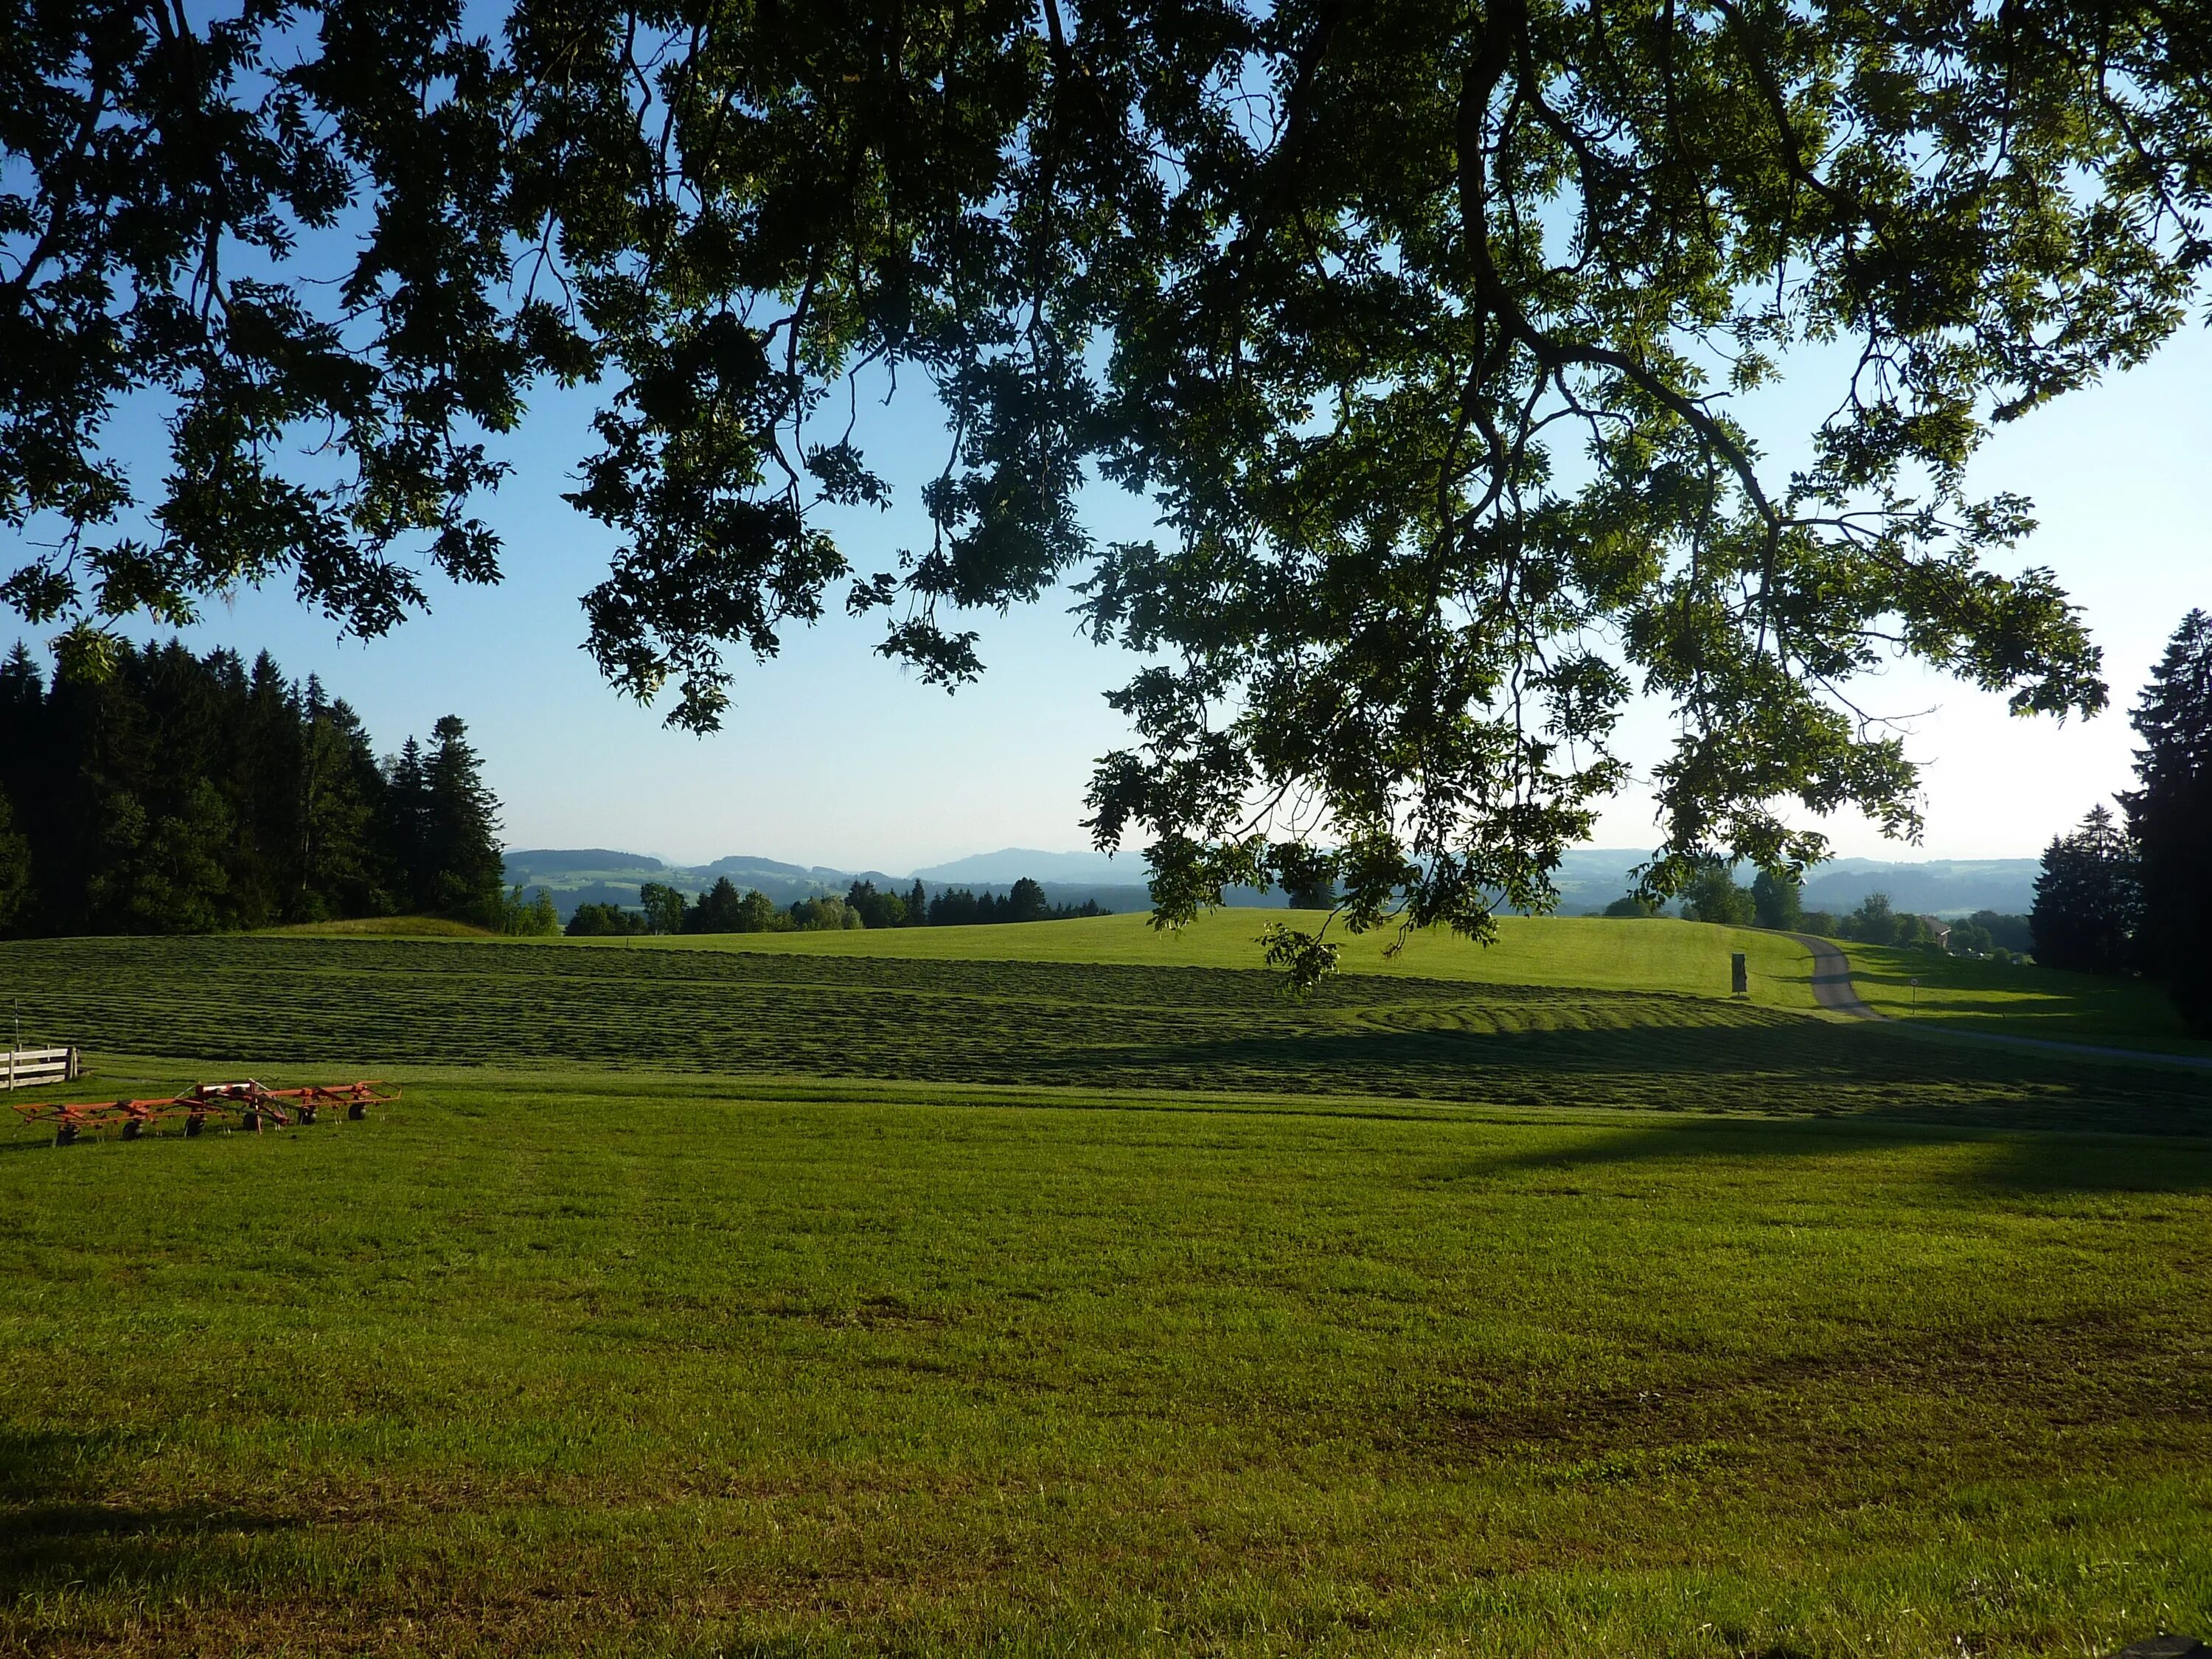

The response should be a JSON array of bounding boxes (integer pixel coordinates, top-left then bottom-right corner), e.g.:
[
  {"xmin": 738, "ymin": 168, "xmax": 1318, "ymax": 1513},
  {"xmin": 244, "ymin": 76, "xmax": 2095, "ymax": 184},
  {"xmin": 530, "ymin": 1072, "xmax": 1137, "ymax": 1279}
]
[{"xmin": 2121, "ymin": 611, "xmax": 2212, "ymax": 1033}]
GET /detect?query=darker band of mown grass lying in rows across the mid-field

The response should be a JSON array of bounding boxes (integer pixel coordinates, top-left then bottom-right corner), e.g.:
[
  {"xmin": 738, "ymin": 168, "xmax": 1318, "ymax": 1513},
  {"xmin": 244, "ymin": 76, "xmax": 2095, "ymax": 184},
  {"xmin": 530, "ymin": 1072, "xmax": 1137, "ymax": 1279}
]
[{"xmin": 0, "ymin": 938, "xmax": 2212, "ymax": 1133}]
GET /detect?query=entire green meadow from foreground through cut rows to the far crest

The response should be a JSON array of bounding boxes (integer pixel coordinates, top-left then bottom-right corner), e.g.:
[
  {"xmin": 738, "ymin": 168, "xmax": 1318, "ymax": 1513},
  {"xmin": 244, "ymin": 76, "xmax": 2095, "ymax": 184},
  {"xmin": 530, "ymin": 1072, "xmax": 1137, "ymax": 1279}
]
[{"xmin": 0, "ymin": 914, "xmax": 2212, "ymax": 1659}]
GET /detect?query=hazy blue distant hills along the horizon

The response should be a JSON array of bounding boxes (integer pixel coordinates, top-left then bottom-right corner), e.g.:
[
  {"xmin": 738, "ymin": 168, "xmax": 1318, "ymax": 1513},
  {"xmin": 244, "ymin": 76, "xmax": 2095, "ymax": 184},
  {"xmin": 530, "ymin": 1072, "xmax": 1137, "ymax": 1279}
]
[{"xmin": 507, "ymin": 847, "xmax": 2039, "ymax": 920}]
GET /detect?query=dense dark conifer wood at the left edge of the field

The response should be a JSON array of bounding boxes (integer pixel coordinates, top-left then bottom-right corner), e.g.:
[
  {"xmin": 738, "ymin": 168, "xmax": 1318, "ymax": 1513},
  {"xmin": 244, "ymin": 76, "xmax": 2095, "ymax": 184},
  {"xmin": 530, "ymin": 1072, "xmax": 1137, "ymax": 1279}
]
[{"xmin": 0, "ymin": 639, "xmax": 540, "ymax": 933}]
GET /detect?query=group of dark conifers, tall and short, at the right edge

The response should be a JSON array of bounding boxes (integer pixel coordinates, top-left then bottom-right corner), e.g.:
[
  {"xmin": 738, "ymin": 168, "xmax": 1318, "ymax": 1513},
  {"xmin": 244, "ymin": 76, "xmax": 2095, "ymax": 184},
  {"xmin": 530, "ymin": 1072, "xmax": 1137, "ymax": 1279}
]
[{"xmin": 2031, "ymin": 611, "xmax": 2212, "ymax": 1035}]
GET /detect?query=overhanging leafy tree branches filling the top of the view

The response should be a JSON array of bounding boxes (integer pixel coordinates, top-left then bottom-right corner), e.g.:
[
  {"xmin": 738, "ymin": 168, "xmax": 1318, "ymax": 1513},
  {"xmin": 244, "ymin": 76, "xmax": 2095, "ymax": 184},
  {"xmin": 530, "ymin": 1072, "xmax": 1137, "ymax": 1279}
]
[{"xmin": 0, "ymin": 0, "xmax": 2212, "ymax": 973}]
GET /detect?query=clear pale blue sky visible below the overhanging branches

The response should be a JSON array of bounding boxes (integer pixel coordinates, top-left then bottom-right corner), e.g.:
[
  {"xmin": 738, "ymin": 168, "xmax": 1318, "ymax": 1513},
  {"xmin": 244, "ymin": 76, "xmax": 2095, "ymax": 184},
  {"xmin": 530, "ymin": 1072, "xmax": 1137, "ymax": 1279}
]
[{"xmin": 0, "ymin": 316, "xmax": 2212, "ymax": 880}]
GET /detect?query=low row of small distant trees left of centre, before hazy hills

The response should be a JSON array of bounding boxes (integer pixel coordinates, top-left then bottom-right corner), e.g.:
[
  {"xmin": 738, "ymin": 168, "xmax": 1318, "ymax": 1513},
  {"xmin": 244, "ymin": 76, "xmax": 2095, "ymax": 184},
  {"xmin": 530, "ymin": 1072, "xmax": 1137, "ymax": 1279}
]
[{"xmin": 568, "ymin": 876, "xmax": 1108, "ymax": 938}]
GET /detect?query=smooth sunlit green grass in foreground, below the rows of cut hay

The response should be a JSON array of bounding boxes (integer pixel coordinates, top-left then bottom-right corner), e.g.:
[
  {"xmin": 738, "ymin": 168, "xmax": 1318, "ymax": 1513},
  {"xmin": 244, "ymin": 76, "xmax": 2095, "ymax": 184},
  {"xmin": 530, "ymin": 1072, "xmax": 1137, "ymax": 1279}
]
[{"xmin": 0, "ymin": 1068, "xmax": 2212, "ymax": 1659}]
